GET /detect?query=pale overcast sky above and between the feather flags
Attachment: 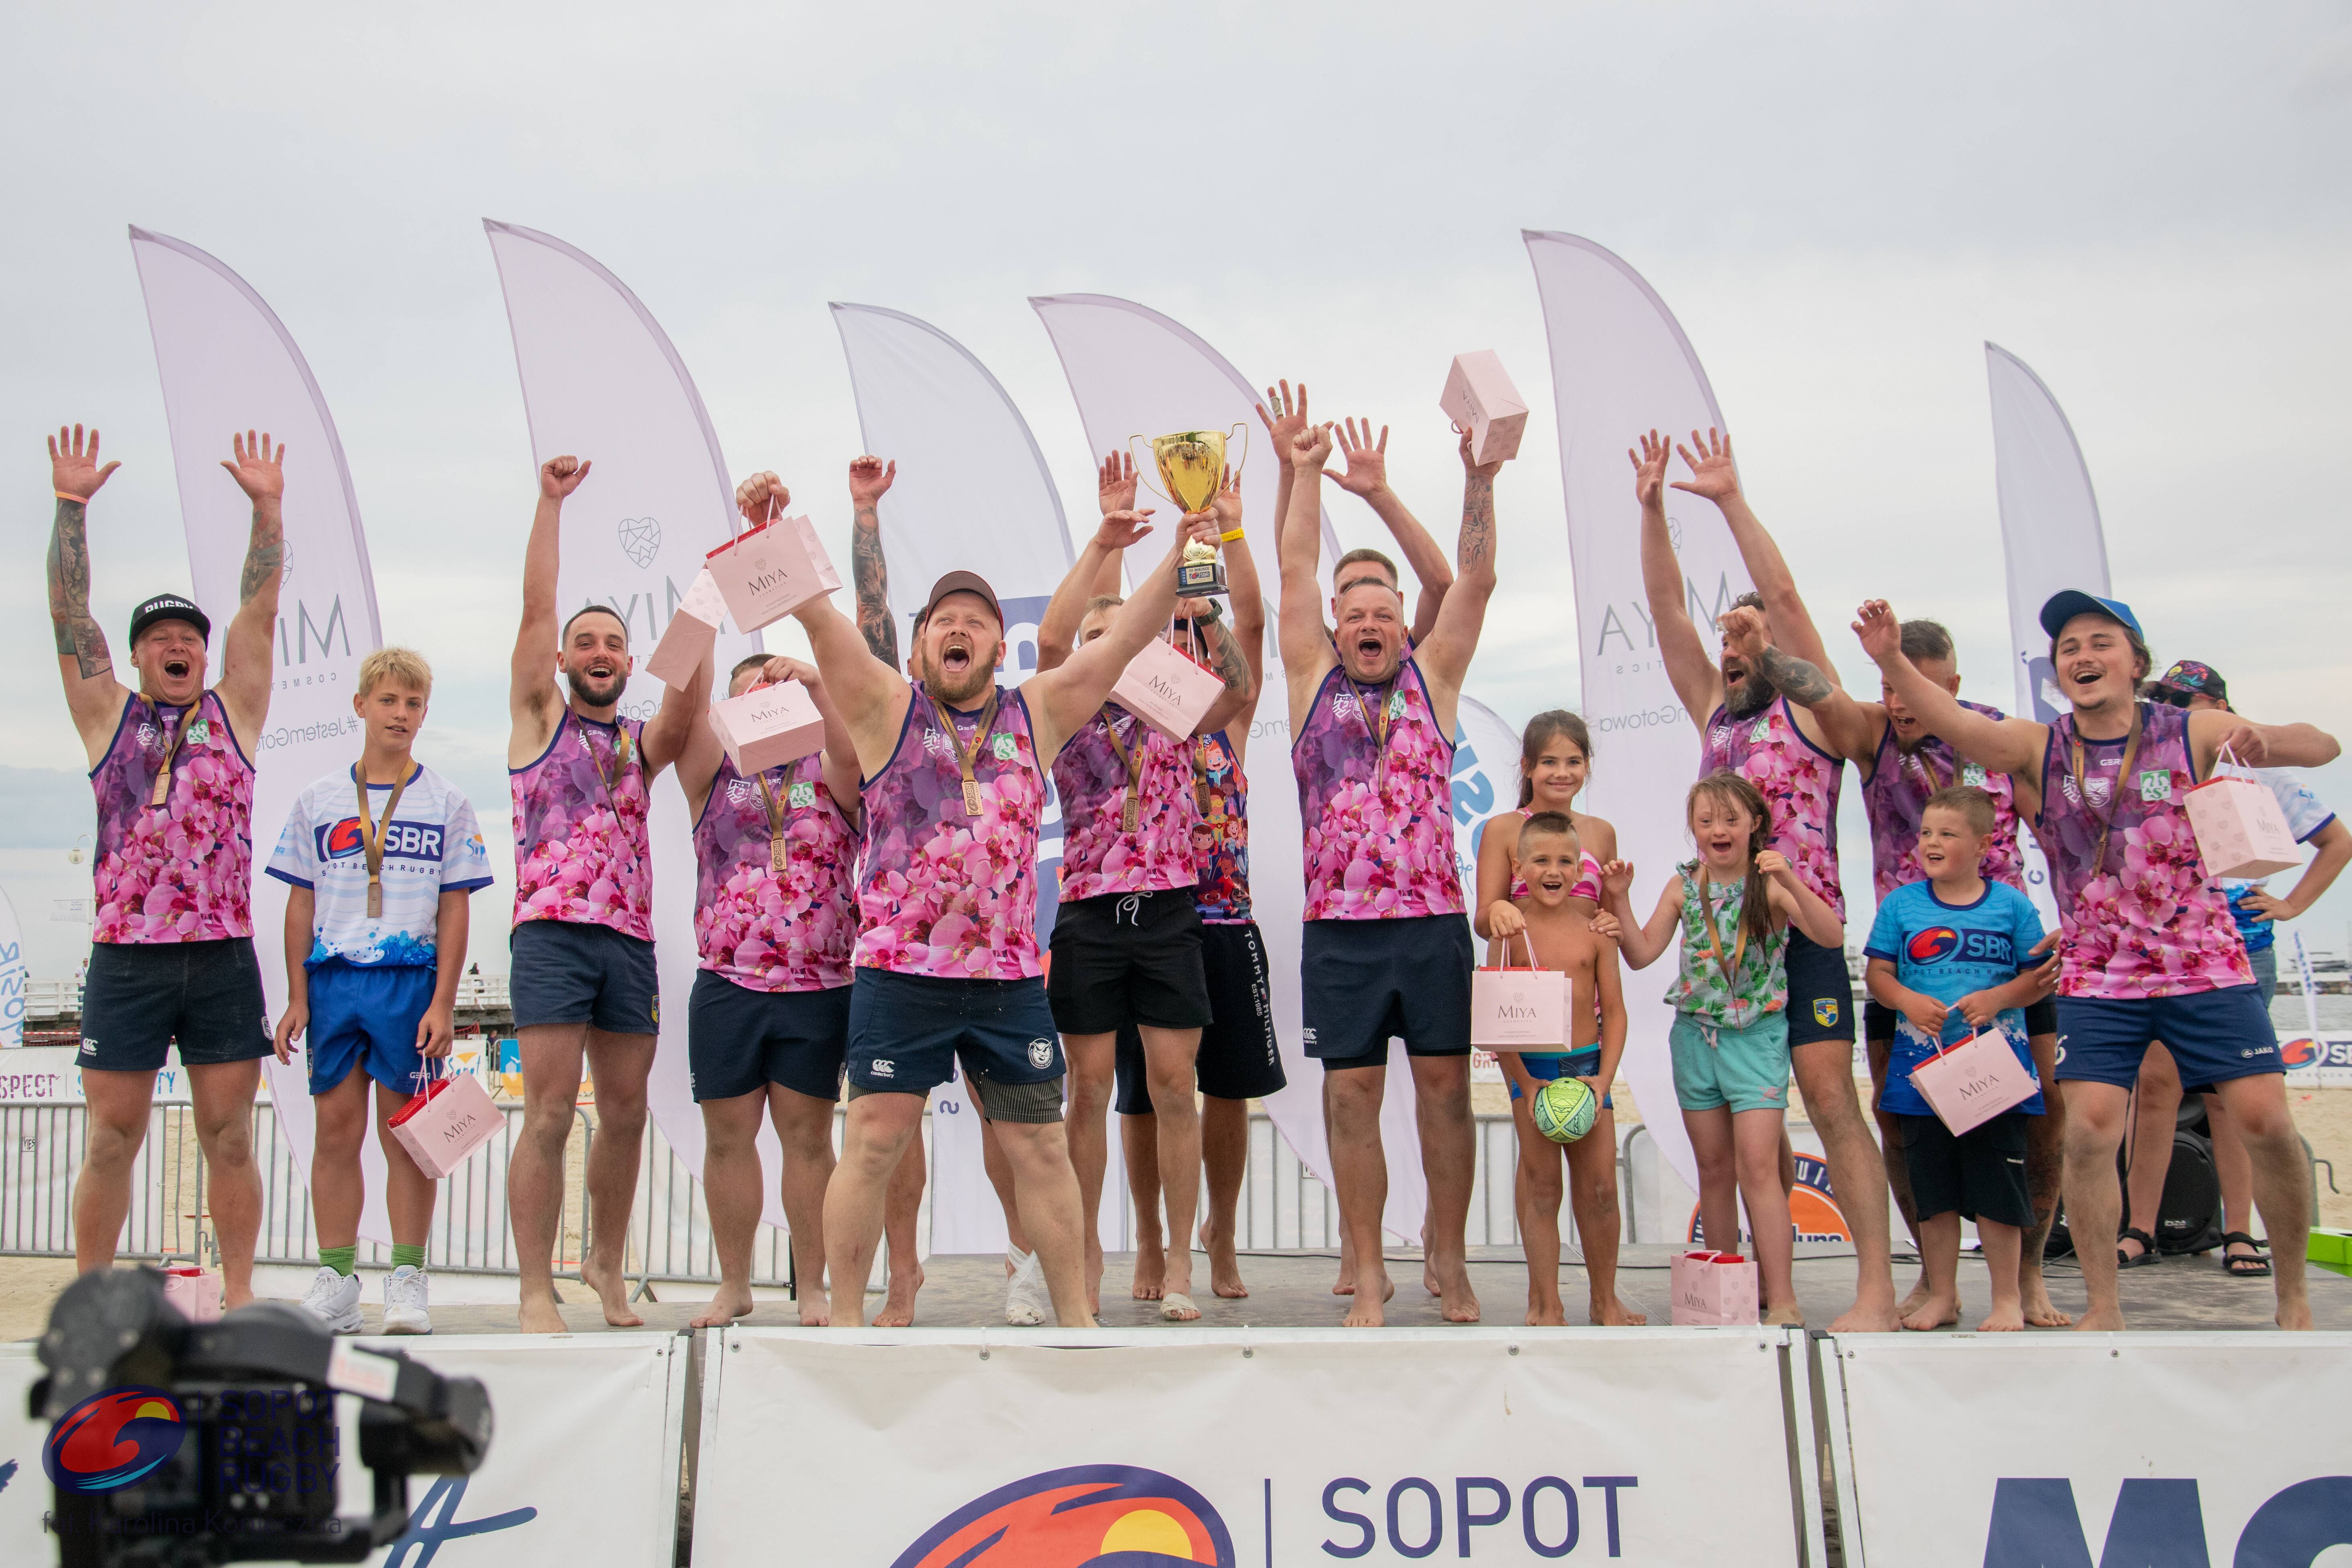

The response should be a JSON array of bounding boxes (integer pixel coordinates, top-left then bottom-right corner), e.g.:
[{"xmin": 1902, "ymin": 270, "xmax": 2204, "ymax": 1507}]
[{"xmin": 0, "ymin": 5, "xmax": 2352, "ymax": 973}]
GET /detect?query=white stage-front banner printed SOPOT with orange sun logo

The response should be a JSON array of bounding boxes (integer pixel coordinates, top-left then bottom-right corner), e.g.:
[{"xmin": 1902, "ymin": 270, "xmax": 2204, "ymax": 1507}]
[{"xmin": 694, "ymin": 1328, "xmax": 1818, "ymax": 1568}]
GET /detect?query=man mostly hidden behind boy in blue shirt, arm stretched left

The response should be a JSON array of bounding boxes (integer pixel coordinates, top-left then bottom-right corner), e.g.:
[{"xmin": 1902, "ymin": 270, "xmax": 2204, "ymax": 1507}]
[{"xmin": 1724, "ymin": 609, "xmax": 2075, "ymax": 1328}]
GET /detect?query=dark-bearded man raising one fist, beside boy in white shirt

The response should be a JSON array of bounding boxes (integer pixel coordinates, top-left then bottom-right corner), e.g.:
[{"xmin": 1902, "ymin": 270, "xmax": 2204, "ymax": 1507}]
[{"xmin": 506, "ymin": 456, "xmax": 694, "ymax": 1333}]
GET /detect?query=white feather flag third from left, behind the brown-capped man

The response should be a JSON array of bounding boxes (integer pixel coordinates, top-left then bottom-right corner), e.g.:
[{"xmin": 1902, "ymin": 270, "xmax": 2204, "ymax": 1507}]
[{"xmin": 832, "ymin": 303, "xmax": 1082, "ymax": 1253}]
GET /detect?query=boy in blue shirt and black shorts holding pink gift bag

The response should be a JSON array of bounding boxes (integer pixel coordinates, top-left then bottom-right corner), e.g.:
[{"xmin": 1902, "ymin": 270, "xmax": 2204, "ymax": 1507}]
[{"xmin": 1863, "ymin": 785, "xmax": 2051, "ymax": 1333}]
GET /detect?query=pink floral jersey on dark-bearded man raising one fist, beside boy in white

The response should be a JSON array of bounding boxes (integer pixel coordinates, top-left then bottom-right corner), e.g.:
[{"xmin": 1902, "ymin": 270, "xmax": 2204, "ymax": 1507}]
[{"xmin": 508, "ymin": 708, "xmax": 654, "ymax": 943}]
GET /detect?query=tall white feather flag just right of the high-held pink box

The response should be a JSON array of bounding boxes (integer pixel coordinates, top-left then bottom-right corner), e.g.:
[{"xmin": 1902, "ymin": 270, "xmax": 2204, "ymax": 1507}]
[{"xmin": 1524, "ymin": 230, "xmax": 1750, "ymax": 1187}]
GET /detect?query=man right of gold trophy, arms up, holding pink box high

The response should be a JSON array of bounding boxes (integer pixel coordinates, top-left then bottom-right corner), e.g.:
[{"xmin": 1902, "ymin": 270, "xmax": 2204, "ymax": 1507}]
[{"xmin": 1279, "ymin": 414, "xmax": 1503, "ymax": 1328}]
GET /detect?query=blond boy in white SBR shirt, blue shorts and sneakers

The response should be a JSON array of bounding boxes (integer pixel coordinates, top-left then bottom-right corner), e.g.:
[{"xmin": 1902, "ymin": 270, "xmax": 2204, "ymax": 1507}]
[{"xmin": 268, "ymin": 649, "xmax": 489, "ymax": 1333}]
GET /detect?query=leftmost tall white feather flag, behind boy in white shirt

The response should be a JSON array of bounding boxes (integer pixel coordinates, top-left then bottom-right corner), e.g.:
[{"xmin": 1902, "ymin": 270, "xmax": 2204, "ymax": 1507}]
[{"xmin": 132, "ymin": 228, "xmax": 393, "ymax": 1241}]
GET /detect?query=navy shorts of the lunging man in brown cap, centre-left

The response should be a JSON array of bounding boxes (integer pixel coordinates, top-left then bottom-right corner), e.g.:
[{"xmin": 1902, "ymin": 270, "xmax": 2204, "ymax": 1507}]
[{"xmin": 849, "ymin": 969, "xmax": 1063, "ymax": 1121}]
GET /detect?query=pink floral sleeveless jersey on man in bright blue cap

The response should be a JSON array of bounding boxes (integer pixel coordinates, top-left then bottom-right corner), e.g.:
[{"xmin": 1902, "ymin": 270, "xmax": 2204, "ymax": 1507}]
[{"xmin": 2034, "ymin": 703, "xmax": 2253, "ymax": 999}]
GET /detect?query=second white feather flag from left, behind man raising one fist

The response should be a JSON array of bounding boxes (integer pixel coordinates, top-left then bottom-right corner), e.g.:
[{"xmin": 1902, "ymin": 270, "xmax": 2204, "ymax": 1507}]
[{"xmin": 477, "ymin": 218, "xmax": 762, "ymax": 1225}]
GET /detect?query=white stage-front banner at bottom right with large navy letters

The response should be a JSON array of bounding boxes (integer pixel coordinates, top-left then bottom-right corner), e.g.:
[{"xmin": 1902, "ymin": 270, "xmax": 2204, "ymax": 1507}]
[{"xmin": 1820, "ymin": 1333, "xmax": 2352, "ymax": 1568}]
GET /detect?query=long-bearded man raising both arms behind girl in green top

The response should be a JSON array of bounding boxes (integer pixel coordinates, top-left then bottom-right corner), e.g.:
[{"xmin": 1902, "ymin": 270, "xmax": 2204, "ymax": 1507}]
[{"xmin": 1625, "ymin": 430, "xmax": 1900, "ymax": 1333}]
